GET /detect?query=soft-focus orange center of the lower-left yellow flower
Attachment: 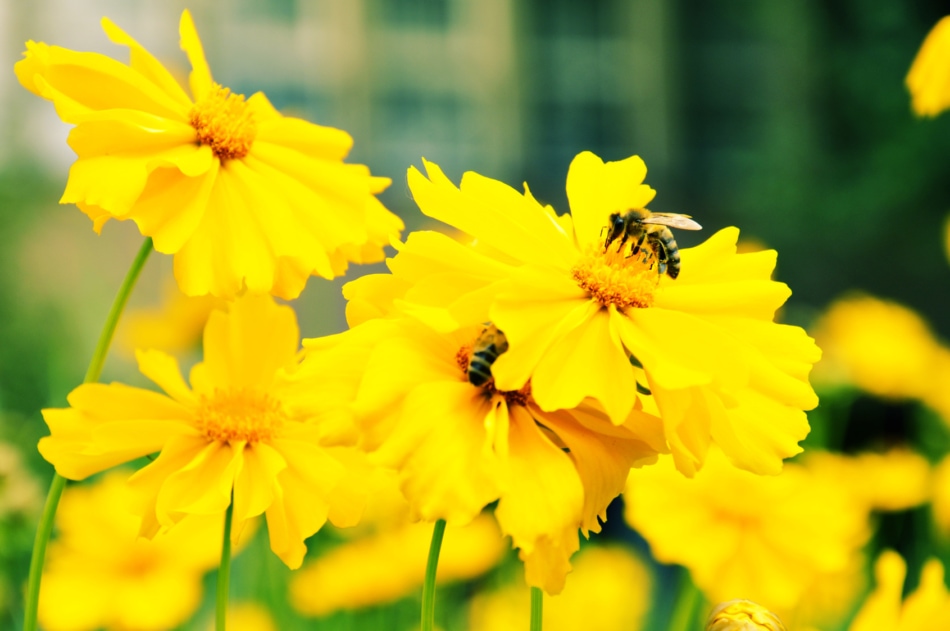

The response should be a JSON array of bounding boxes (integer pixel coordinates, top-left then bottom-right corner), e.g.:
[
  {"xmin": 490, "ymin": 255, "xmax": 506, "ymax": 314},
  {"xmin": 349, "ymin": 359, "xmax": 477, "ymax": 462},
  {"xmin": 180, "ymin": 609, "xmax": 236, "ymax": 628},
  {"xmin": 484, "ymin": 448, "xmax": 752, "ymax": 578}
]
[{"xmin": 195, "ymin": 388, "xmax": 287, "ymax": 443}]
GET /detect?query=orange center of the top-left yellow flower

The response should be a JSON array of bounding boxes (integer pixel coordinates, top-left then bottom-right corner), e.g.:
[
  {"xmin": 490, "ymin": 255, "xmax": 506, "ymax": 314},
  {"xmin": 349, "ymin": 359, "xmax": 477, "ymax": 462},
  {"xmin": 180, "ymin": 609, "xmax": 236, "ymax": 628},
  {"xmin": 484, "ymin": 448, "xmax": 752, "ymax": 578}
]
[{"xmin": 188, "ymin": 83, "xmax": 257, "ymax": 160}]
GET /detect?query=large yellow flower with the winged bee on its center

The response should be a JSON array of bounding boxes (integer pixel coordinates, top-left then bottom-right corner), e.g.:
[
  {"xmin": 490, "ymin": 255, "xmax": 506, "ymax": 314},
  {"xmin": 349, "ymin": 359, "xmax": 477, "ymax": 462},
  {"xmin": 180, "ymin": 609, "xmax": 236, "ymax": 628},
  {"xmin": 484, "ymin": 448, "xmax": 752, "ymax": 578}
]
[{"xmin": 344, "ymin": 152, "xmax": 820, "ymax": 474}]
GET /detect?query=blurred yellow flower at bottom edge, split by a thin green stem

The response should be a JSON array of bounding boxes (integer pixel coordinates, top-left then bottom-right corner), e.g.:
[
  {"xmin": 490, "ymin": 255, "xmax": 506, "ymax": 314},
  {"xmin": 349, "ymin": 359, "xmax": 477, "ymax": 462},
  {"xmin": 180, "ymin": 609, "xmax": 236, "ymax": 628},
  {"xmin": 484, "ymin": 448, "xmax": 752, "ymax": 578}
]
[{"xmin": 468, "ymin": 545, "xmax": 653, "ymax": 631}]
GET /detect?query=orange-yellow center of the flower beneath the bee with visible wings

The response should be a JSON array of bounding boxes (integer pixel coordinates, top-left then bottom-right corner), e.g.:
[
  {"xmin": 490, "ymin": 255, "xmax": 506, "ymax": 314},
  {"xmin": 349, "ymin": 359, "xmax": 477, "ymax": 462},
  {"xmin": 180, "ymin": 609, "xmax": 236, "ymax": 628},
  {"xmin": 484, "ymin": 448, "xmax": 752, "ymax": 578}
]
[{"xmin": 571, "ymin": 241, "xmax": 660, "ymax": 309}]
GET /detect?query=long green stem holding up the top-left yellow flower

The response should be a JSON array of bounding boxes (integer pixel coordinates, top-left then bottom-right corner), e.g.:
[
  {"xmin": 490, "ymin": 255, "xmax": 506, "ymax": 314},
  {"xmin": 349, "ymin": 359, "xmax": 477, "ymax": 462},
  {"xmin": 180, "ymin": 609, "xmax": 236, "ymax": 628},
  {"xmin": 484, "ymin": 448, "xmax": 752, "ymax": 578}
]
[{"xmin": 23, "ymin": 238, "xmax": 152, "ymax": 631}]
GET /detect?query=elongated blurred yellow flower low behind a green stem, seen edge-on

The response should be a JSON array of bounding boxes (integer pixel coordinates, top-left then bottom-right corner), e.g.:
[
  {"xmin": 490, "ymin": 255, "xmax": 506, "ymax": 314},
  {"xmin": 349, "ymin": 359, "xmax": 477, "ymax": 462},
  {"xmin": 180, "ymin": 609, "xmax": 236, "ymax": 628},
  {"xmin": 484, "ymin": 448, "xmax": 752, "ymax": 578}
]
[{"xmin": 290, "ymin": 515, "xmax": 504, "ymax": 616}]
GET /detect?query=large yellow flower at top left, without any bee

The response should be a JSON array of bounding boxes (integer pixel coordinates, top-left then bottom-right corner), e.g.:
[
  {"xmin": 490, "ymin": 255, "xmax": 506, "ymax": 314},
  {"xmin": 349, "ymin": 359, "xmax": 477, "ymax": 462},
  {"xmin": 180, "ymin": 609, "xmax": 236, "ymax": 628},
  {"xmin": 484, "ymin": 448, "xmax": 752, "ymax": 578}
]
[{"xmin": 15, "ymin": 11, "xmax": 403, "ymax": 298}]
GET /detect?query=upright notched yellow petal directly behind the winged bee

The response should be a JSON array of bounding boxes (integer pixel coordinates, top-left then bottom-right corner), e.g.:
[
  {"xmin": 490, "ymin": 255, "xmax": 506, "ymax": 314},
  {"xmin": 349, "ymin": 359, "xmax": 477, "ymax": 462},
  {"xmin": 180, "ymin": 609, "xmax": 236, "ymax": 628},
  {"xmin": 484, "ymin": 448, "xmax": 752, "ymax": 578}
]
[{"xmin": 567, "ymin": 151, "xmax": 656, "ymax": 249}]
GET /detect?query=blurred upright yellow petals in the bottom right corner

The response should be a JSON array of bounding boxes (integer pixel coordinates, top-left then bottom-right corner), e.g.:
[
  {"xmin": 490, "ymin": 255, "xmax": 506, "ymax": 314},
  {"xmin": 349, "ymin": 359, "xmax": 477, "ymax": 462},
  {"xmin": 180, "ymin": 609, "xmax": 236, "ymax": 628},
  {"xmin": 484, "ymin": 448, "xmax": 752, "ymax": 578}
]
[{"xmin": 848, "ymin": 550, "xmax": 950, "ymax": 631}]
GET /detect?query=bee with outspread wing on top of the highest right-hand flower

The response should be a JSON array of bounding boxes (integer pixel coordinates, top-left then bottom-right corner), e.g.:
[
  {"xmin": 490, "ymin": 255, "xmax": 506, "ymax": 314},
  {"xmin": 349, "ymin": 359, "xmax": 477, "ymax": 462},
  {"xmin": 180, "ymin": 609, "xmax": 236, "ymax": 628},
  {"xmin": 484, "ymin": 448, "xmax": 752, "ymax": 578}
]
[{"xmin": 604, "ymin": 208, "xmax": 702, "ymax": 278}]
